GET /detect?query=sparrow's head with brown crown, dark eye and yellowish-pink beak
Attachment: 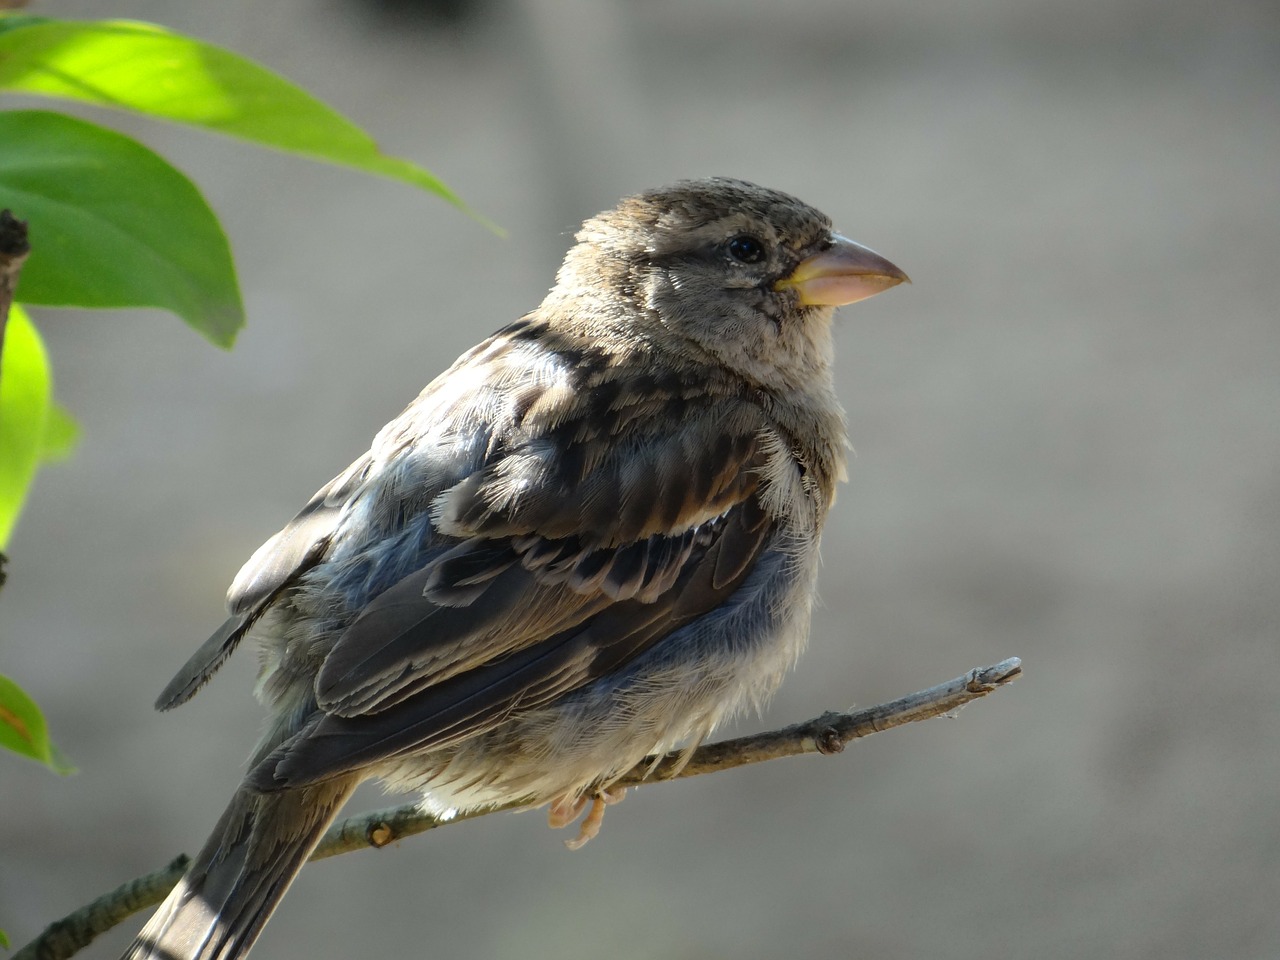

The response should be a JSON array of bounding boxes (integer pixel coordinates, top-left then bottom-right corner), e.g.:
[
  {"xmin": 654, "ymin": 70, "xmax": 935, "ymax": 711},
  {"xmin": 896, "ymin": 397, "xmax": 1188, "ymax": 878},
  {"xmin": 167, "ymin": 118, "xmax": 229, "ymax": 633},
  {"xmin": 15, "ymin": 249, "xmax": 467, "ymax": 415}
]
[{"xmin": 548, "ymin": 178, "xmax": 908, "ymax": 389}]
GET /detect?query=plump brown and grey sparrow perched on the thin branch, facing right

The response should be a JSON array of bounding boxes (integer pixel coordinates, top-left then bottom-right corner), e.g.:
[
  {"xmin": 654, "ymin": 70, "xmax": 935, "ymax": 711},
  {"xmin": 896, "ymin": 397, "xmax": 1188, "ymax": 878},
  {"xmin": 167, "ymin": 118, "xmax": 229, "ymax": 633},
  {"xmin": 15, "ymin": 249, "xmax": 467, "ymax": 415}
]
[{"xmin": 117, "ymin": 178, "xmax": 908, "ymax": 960}]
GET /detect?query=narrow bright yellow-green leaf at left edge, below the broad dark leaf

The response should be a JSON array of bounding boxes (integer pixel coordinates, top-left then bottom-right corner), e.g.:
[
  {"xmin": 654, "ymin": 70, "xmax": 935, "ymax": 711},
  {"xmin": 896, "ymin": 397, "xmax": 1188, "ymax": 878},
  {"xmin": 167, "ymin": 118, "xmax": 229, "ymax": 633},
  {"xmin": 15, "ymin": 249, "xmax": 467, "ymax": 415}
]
[{"xmin": 0, "ymin": 303, "xmax": 50, "ymax": 550}]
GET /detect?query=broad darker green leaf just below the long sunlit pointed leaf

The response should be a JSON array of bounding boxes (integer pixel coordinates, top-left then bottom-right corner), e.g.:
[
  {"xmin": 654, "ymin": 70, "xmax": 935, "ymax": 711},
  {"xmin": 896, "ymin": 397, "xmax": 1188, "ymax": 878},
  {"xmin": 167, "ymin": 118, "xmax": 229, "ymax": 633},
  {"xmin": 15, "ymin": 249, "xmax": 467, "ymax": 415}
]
[{"xmin": 0, "ymin": 112, "xmax": 244, "ymax": 347}]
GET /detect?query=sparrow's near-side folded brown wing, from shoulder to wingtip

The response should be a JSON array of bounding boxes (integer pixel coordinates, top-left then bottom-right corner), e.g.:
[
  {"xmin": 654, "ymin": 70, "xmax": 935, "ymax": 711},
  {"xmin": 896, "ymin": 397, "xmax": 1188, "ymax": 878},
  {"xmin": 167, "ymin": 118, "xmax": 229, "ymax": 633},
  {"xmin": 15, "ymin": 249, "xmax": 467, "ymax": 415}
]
[{"xmin": 241, "ymin": 337, "xmax": 774, "ymax": 788}]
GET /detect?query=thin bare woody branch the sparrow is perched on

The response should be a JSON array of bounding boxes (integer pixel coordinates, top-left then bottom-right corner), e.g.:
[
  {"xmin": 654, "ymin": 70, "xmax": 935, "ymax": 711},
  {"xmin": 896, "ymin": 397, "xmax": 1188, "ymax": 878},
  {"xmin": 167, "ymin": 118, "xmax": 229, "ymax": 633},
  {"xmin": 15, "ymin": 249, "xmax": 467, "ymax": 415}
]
[{"xmin": 13, "ymin": 657, "xmax": 1023, "ymax": 960}]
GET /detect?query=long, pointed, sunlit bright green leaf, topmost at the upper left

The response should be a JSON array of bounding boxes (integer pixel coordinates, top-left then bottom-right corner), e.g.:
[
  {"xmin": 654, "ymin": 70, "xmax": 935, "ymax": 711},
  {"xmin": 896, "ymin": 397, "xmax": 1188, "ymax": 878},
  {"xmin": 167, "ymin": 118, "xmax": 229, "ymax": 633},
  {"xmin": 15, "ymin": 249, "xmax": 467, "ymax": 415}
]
[{"xmin": 0, "ymin": 17, "xmax": 474, "ymax": 221}]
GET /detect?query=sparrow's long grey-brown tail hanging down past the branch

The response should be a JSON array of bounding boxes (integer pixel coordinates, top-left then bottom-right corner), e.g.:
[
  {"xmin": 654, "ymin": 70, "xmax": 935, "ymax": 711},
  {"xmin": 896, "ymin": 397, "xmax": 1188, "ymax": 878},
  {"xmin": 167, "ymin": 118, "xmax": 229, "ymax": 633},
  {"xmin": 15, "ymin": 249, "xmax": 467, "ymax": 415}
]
[{"xmin": 122, "ymin": 778, "xmax": 357, "ymax": 960}]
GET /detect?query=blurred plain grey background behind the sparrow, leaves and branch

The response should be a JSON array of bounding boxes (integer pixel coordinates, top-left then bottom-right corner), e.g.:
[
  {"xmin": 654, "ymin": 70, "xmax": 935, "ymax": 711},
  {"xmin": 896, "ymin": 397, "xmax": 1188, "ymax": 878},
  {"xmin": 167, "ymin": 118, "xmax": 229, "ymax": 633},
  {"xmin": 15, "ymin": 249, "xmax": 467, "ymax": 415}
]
[{"xmin": 0, "ymin": 0, "xmax": 1280, "ymax": 960}]
